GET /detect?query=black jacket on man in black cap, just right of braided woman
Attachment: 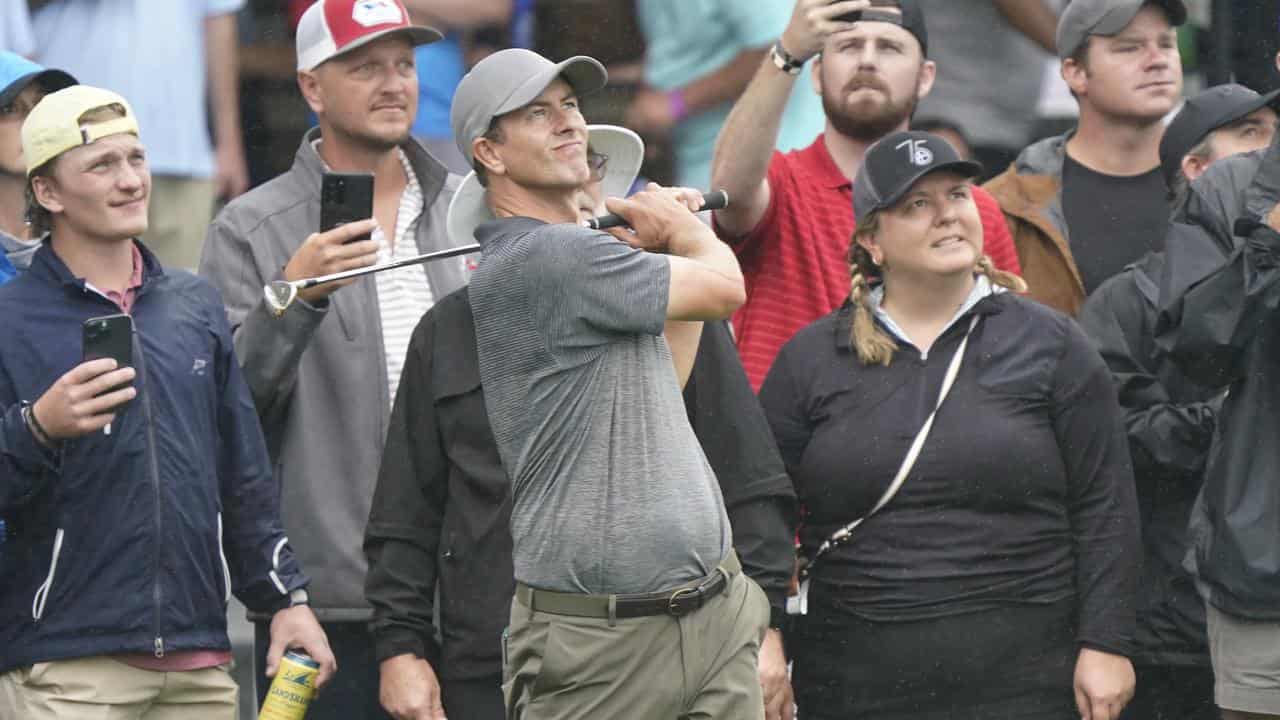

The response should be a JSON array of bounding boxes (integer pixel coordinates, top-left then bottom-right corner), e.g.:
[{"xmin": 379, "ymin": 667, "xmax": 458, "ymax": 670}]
[{"xmin": 1079, "ymin": 234, "xmax": 1224, "ymax": 666}]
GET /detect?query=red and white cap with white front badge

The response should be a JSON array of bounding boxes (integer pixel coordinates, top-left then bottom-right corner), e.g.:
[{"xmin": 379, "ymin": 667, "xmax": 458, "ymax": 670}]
[{"xmin": 297, "ymin": 0, "xmax": 442, "ymax": 72}]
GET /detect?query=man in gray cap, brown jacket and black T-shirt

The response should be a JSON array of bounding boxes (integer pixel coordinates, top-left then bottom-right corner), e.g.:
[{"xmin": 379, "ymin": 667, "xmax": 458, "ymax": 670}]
[{"xmin": 986, "ymin": 0, "xmax": 1187, "ymax": 315}]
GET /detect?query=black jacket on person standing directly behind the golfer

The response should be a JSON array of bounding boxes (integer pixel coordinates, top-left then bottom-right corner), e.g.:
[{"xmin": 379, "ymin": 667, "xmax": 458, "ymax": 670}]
[{"xmin": 365, "ymin": 283, "xmax": 795, "ymax": 679}]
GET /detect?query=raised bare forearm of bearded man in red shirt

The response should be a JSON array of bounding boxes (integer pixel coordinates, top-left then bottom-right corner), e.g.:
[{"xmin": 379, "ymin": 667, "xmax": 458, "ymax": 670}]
[{"xmin": 712, "ymin": 58, "xmax": 796, "ymax": 234}]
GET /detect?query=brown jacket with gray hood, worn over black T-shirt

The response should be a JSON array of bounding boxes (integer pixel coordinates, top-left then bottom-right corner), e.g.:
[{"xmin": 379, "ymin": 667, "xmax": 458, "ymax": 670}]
[{"xmin": 983, "ymin": 133, "xmax": 1084, "ymax": 316}]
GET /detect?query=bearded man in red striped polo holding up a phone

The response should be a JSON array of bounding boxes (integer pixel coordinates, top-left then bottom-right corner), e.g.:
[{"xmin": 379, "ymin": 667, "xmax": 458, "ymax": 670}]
[{"xmin": 712, "ymin": 0, "xmax": 1019, "ymax": 389}]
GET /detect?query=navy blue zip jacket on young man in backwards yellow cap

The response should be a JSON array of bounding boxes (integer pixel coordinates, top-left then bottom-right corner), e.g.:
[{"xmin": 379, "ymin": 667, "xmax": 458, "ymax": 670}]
[{"xmin": 0, "ymin": 242, "xmax": 307, "ymax": 671}]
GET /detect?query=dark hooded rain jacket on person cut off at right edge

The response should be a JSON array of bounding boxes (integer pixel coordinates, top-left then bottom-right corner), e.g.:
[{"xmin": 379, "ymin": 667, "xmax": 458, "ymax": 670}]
[{"xmin": 1156, "ymin": 128, "xmax": 1280, "ymax": 621}]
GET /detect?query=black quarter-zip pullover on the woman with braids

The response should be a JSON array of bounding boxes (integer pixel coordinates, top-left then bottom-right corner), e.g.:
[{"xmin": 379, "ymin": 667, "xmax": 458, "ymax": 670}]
[{"xmin": 760, "ymin": 288, "xmax": 1140, "ymax": 655}]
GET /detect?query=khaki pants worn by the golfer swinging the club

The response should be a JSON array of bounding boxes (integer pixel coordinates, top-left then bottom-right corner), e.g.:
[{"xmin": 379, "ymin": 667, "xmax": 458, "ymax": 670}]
[{"xmin": 502, "ymin": 573, "xmax": 769, "ymax": 720}]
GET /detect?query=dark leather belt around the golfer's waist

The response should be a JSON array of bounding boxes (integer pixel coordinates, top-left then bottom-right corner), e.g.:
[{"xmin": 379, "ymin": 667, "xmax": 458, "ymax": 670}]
[{"xmin": 516, "ymin": 551, "xmax": 742, "ymax": 620}]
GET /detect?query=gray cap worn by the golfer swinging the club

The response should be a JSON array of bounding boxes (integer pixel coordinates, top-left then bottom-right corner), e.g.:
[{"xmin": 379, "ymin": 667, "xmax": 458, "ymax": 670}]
[{"xmin": 449, "ymin": 47, "xmax": 609, "ymax": 164}]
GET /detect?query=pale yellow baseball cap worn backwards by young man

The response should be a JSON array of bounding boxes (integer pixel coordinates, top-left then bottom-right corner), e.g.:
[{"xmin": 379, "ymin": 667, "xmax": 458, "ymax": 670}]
[{"xmin": 22, "ymin": 85, "xmax": 140, "ymax": 177}]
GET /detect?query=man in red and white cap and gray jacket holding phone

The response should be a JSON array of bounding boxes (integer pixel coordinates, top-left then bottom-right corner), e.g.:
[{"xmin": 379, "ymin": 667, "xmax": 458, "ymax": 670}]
[{"xmin": 201, "ymin": 0, "xmax": 468, "ymax": 720}]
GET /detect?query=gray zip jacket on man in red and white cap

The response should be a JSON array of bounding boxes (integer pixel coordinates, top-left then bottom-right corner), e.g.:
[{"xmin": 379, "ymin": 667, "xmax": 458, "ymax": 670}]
[{"xmin": 200, "ymin": 129, "xmax": 470, "ymax": 621}]
